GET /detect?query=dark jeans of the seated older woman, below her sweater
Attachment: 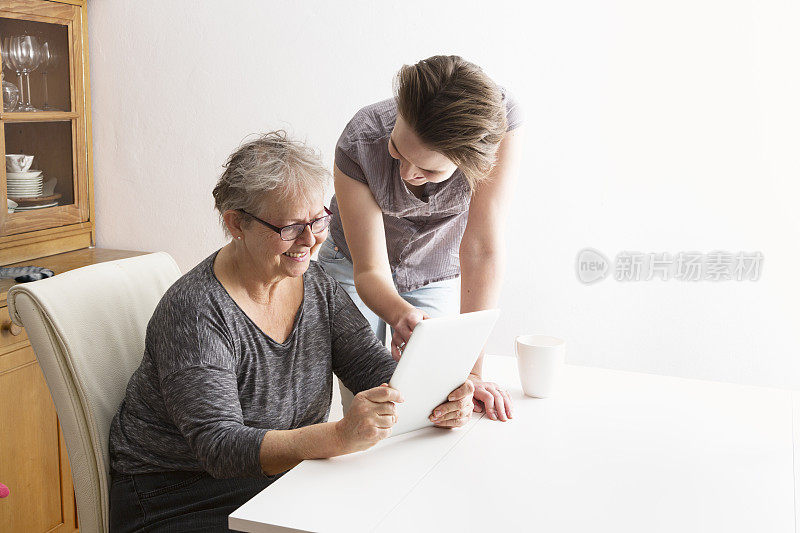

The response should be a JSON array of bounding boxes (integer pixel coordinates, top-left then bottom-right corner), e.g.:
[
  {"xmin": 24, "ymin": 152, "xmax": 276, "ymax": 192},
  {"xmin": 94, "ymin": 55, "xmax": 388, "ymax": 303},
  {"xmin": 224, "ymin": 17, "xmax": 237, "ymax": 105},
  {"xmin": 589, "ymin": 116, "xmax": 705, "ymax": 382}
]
[{"xmin": 108, "ymin": 472, "xmax": 276, "ymax": 533}]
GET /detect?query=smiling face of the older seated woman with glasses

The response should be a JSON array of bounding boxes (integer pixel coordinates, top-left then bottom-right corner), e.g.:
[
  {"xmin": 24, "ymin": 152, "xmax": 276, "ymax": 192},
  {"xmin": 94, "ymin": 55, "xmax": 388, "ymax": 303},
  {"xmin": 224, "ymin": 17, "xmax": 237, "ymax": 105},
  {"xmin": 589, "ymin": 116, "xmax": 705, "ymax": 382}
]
[{"xmin": 231, "ymin": 192, "xmax": 328, "ymax": 280}]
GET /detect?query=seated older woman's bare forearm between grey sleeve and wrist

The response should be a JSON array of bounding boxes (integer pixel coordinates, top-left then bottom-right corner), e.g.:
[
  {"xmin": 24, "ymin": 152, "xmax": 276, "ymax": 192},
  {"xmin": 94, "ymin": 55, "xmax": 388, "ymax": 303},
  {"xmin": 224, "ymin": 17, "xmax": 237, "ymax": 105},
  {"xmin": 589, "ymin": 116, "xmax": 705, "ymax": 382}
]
[{"xmin": 259, "ymin": 422, "xmax": 347, "ymax": 475}]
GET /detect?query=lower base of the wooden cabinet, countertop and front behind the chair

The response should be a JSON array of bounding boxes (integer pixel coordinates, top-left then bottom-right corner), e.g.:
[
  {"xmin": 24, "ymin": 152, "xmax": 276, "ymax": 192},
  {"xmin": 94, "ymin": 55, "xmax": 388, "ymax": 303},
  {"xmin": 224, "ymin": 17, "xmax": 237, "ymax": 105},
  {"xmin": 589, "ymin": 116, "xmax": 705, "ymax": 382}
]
[{"xmin": 0, "ymin": 248, "xmax": 143, "ymax": 533}]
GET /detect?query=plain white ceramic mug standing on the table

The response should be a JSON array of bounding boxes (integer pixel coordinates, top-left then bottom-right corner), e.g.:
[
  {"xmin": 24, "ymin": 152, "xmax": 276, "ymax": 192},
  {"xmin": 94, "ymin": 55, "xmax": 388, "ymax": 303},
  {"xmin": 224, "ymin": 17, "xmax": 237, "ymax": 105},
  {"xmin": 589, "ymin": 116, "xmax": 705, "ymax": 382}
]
[{"xmin": 514, "ymin": 335, "xmax": 566, "ymax": 398}]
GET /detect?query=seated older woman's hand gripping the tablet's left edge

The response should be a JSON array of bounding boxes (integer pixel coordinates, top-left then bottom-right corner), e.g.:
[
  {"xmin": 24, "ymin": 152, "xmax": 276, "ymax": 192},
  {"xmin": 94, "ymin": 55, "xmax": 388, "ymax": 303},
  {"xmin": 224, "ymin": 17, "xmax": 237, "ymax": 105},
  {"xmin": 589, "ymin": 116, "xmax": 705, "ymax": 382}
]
[{"xmin": 335, "ymin": 383, "xmax": 403, "ymax": 453}]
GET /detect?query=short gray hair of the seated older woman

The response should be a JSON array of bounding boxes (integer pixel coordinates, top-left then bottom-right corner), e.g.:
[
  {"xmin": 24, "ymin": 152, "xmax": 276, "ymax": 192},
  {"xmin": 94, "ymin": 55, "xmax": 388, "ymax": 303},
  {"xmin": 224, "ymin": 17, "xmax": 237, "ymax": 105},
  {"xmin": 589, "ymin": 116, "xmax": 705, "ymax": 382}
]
[{"xmin": 213, "ymin": 130, "xmax": 330, "ymax": 235}]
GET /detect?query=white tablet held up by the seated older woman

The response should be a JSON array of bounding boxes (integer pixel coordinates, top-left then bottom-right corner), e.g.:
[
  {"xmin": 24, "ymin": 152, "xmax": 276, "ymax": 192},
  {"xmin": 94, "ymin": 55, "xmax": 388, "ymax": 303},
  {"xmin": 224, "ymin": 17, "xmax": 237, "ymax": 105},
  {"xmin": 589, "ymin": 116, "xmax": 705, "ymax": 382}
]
[{"xmin": 389, "ymin": 309, "xmax": 500, "ymax": 435}]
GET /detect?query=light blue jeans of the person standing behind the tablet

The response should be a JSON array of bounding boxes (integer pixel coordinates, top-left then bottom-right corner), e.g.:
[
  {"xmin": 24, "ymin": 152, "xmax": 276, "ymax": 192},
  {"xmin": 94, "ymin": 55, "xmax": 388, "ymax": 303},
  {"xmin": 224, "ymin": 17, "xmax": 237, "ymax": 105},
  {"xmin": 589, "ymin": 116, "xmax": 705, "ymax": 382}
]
[{"xmin": 317, "ymin": 236, "xmax": 461, "ymax": 412}]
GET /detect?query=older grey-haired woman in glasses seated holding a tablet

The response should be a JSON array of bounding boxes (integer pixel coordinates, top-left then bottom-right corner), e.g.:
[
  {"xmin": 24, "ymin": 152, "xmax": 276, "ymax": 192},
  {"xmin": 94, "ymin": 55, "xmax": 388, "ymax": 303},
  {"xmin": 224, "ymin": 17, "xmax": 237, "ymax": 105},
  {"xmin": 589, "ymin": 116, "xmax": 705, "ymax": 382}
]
[{"xmin": 104, "ymin": 132, "xmax": 473, "ymax": 531}]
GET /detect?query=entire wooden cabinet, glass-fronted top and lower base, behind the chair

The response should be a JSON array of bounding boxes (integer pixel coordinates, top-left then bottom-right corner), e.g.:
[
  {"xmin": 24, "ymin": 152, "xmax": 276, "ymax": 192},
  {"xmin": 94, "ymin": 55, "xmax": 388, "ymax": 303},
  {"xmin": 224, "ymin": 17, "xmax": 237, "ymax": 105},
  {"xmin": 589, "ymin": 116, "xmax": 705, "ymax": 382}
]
[{"xmin": 0, "ymin": 0, "xmax": 141, "ymax": 533}]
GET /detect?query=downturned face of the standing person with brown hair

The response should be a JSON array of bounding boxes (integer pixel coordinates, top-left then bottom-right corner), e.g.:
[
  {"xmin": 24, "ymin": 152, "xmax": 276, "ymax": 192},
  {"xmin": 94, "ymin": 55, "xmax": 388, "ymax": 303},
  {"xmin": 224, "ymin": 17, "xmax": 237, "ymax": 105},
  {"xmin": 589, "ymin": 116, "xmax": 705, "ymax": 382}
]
[{"xmin": 389, "ymin": 115, "xmax": 457, "ymax": 185}]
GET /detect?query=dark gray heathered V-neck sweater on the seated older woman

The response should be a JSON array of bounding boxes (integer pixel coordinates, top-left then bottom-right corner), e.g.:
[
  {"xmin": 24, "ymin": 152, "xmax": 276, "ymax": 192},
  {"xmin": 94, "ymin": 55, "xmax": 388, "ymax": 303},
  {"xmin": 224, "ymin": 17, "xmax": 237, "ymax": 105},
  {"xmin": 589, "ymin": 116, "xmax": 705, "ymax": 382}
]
[{"xmin": 109, "ymin": 252, "xmax": 396, "ymax": 478}]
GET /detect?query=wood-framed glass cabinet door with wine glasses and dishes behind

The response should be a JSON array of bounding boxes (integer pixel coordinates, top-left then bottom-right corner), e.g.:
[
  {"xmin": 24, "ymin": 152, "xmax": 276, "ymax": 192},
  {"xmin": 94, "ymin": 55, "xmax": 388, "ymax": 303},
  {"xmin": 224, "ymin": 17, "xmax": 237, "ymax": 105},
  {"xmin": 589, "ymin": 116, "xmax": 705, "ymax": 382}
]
[{"xmin": 0, "ymin": 1, "xmax": 89, "ymax": 235}]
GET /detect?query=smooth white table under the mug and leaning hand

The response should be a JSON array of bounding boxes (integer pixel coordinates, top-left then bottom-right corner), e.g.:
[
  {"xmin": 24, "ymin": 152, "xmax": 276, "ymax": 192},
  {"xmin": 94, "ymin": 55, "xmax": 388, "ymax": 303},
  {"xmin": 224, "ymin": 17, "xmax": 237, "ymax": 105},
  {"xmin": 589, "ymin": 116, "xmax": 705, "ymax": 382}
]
[{"xmin": 229, "ymin": 357, "xmax": 800, "ymax": 533}]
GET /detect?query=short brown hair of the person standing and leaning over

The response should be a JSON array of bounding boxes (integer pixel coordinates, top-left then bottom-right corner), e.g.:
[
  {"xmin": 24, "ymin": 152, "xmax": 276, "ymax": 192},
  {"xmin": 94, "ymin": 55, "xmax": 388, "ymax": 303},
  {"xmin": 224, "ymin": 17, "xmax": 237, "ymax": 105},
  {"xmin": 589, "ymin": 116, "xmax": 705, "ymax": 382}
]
[{"xmin": 395, "ymin": 56, "xmax": 507, "ymax": 191}]
